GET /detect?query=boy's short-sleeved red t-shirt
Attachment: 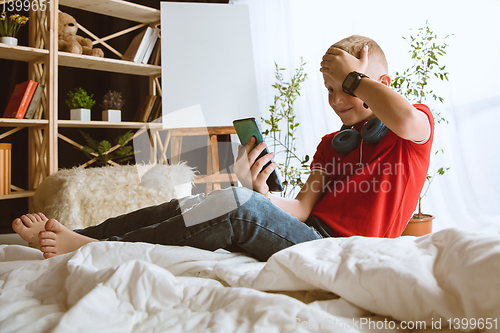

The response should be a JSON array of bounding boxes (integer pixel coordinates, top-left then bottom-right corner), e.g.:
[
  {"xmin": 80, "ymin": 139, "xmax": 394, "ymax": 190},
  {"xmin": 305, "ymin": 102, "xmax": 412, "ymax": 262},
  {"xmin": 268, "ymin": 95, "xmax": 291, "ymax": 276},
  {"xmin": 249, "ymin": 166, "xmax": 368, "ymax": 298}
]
[{"xmin": 311, "ymin": 104, "xmax": 434, "ymax": 238}]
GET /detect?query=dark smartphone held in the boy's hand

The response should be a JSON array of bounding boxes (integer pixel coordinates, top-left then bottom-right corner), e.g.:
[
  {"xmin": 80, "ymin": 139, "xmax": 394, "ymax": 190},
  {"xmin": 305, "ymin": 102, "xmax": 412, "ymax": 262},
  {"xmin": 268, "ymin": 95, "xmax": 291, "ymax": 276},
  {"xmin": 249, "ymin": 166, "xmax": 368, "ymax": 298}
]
[{"xmin": 233, "ymin": 118, "xmax": 283, "ymax": 192}]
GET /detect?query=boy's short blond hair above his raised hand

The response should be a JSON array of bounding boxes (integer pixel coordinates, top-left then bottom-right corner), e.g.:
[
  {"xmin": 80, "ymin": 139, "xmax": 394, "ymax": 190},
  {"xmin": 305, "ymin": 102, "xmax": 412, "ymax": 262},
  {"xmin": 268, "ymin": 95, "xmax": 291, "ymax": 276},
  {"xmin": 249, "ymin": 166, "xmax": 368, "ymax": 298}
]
[{"xmin": 332, "ymin": 35, "xmax": 389, "ymax": 80}]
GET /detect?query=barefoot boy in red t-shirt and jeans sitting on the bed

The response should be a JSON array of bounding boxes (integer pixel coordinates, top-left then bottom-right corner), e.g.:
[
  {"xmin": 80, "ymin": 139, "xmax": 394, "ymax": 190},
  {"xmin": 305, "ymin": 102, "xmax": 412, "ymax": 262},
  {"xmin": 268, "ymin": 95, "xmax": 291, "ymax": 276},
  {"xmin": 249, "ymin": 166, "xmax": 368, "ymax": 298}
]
[{"xmin": 13, "ymin": 36, "xmax": 433, "ymax": 260}]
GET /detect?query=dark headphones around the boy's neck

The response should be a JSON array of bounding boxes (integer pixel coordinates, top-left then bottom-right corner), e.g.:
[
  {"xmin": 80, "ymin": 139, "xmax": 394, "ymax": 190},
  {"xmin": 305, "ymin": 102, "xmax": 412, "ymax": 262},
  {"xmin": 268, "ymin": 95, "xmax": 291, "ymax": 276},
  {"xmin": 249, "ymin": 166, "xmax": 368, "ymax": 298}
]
[{"xmin": 332, "ymin": 118, "xmax": 389, "ymax": 155}]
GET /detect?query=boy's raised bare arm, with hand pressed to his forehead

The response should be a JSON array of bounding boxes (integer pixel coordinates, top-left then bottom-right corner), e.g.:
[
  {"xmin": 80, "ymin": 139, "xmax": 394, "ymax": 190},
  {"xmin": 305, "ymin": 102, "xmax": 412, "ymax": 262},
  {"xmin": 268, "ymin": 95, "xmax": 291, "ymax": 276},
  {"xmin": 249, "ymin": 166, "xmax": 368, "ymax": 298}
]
[{"xmin": 321, "ymin": 46, "xmax": 430, "ymax": 142}]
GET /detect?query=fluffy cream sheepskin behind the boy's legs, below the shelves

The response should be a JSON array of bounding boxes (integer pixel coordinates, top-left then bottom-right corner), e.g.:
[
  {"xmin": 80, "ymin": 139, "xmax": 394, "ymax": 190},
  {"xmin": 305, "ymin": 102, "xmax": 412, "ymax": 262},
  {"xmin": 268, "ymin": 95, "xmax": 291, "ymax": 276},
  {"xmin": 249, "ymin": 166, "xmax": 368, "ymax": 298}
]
[{"xmin": 33, "ymin": 164, "xmax": 194, "ymax": 229}]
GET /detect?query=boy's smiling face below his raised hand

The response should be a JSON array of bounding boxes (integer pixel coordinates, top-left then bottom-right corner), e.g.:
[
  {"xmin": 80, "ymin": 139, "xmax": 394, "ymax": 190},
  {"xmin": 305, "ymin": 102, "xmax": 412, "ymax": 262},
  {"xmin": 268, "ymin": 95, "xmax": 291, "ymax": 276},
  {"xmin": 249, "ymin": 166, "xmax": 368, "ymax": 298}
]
[{"xmin": 323, "ymin": 74, "xmax": 375, "ymax": 126}]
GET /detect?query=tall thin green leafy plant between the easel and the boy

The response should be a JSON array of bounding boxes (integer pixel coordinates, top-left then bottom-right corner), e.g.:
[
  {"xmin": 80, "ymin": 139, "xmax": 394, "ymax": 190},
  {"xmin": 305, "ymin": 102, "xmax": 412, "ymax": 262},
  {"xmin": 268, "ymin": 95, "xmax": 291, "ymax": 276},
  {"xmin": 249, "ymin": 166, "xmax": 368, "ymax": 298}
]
[{"xmin": 262, "ymin": 58, "xmax": 309, "ymax": 197}]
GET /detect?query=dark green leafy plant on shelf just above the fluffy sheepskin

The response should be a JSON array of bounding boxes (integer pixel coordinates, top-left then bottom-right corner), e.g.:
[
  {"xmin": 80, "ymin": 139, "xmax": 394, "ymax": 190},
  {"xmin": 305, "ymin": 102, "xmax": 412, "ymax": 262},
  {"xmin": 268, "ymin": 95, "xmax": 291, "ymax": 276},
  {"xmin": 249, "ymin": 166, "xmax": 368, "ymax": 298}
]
[{"xmin": 80, "ymin": 131, "xmax": 137, "ymax": 166}]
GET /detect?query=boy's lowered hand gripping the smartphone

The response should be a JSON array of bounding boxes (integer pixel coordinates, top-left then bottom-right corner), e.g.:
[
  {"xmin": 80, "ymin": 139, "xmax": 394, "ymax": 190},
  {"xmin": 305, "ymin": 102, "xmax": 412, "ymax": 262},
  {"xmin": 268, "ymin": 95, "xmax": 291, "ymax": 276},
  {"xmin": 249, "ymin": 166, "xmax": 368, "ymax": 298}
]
[{"xmin": 234, "ymin": 136, "xmax": 277, "ymax": 196}]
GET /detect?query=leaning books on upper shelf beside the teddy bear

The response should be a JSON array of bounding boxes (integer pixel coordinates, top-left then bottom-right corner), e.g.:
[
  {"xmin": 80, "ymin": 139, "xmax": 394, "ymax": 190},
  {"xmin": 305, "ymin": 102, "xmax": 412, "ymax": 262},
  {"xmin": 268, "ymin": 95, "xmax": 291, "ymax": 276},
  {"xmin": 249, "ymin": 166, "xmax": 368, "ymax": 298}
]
[{"xmin": 122, "ymin": 27, "xmax": 161, "ymax": 65}]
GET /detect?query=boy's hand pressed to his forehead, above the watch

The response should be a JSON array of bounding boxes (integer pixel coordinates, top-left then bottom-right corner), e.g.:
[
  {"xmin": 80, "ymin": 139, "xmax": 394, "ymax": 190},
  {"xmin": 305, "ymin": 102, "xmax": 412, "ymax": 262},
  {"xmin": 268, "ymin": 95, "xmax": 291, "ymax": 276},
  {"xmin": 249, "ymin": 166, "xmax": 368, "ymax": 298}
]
[{"xmin": 320, "ymin": 45, "xmax": 368, "ymax": 85}]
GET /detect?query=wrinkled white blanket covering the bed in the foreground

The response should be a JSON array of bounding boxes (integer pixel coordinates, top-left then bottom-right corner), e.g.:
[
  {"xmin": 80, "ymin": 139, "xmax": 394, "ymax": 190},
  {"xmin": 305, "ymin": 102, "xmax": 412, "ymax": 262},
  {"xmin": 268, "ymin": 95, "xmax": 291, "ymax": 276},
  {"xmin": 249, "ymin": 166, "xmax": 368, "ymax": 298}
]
[{"xmin": 0, "ymin": 229, "xmax": 500, "ymax": 333}]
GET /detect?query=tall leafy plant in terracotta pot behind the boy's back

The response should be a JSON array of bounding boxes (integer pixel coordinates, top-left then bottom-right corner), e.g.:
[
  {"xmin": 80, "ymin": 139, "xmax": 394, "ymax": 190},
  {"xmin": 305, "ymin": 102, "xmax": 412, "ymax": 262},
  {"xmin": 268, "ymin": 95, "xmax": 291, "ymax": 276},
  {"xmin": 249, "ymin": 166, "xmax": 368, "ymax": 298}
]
[{"xmin": 391, "ymin": 21, "xmax": 449, "ymax": 236}]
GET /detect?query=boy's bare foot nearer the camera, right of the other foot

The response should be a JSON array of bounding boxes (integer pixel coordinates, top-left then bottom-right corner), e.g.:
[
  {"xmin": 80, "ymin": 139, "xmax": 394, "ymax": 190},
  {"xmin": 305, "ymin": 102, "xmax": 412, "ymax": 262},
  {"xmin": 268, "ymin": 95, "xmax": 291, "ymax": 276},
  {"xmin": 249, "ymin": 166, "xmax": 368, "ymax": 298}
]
[{"xmin": 39, "ymin": 219, "xmax": 97, "ymax": 259}]
